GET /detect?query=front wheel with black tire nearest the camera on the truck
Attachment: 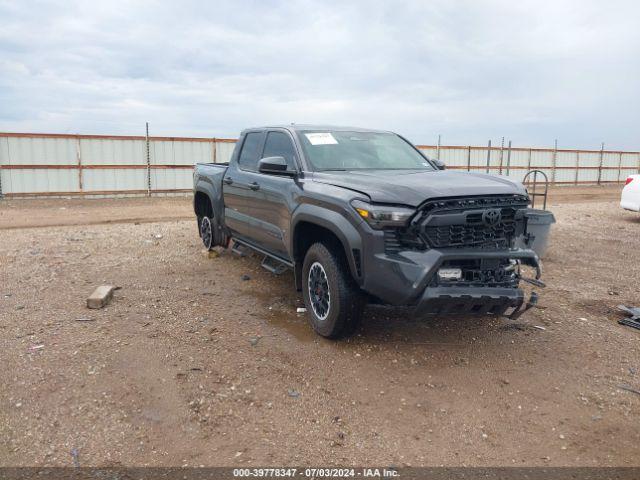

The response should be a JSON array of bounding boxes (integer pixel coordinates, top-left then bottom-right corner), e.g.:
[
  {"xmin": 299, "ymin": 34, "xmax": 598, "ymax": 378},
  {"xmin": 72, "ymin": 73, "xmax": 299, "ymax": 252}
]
[{"xmin": 302, "ymin": 243, "xmax": 364, "ymax": 338}]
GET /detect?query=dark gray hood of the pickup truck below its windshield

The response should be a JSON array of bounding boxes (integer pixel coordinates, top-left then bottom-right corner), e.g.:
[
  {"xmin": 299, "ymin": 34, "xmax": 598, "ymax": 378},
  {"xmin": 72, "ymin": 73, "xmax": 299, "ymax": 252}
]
[{"xmin": 313, "ymin": 170, "xmax": 526, "ymax": 207}]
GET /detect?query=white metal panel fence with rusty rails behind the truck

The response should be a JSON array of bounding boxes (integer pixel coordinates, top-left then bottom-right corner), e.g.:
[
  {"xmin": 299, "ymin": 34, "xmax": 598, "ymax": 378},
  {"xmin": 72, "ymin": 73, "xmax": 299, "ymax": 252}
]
[{"xmin": 0, "ymin": 133, "xmax": 640, "ymax": 197}]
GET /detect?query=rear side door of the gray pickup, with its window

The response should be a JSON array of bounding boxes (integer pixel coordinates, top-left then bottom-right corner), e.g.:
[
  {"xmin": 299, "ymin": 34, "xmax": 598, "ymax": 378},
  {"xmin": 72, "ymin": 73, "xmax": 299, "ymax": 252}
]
[{"xmin": 222, "ymin": 131, "xmax": 265, "ymax": 240}]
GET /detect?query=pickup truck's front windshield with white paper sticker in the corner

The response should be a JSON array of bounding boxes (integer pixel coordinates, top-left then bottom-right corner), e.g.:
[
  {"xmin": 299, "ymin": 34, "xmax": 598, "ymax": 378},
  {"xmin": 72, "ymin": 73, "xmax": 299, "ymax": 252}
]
[{"xmin": 298, "ymin": 130, "xmax": 434, "ymax": 171}]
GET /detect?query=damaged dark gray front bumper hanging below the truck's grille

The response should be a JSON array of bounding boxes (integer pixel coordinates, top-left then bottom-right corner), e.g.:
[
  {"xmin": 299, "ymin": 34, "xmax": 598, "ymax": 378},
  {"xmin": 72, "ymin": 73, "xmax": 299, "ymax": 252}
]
[{"xmin": 363, "ymin": 248, "xmax": 544, "ymax": 318}]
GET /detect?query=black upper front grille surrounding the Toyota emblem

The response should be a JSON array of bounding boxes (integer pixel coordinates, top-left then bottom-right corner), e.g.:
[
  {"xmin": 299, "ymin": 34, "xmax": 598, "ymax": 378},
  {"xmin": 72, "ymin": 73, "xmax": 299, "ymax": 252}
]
[{"xmin": 414, "ymin": 195, "xmax": 528, "ymax": 249}]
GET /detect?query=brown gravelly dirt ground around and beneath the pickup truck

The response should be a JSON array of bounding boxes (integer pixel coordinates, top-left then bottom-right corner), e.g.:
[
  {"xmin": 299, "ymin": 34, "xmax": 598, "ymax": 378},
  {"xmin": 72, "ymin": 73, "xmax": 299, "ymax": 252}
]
[{"xmin": 0, "ymin": 187, "xmax": 640, "ymax": 466}]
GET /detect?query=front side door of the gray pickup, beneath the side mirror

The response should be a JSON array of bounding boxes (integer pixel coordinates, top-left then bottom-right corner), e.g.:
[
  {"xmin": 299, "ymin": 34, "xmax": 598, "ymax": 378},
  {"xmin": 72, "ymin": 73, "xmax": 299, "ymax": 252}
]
[{"xmin": 244, "ymin": 130, "xmax": 299, "ymax": 260}]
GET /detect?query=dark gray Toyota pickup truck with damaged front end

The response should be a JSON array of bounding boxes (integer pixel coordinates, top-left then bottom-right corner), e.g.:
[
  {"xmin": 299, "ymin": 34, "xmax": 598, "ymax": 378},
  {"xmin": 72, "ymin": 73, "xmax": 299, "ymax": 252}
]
[{"xmin": 194, "ymin": 125, "xmax": 542, "ymax": 338}]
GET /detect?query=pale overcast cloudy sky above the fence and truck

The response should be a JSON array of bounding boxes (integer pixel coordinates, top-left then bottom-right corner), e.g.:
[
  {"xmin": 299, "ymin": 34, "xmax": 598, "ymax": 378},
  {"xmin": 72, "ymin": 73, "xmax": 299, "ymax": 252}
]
[{"xmin": 0, "ymin": 0, "xmax": 640, "ymax": 150}]
